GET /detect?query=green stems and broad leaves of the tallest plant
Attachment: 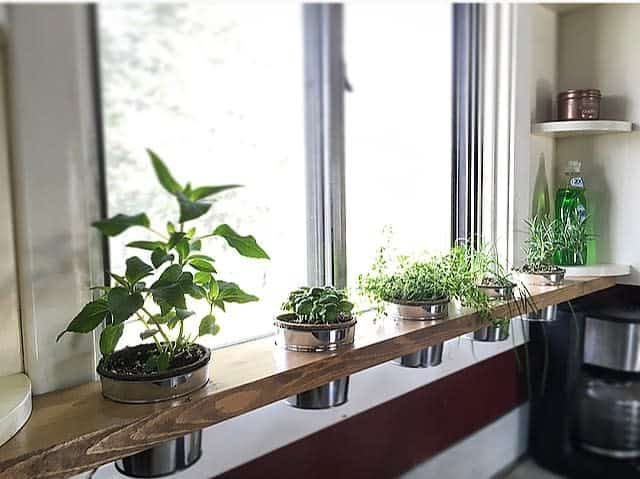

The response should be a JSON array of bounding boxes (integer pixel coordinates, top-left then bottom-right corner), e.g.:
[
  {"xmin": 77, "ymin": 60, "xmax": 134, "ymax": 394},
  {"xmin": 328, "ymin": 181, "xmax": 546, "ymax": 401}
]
[{"xmin": 57, "ymin": 150, "xmax": 269, "ymax": 370}]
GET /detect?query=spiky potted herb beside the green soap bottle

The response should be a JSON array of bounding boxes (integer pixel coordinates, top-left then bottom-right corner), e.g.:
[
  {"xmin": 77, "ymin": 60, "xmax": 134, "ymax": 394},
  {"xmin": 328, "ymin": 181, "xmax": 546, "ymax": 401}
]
[{"xmin": 516, "ymin": 216, "xmax": 565, "ymax": 286}]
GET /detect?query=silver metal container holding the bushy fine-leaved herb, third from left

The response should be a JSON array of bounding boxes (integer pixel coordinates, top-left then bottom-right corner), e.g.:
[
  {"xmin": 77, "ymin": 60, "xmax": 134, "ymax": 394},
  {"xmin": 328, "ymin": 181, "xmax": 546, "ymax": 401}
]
[{"xmin": 385, "ymin": 298, "xmax": 449, "ymax": 368}]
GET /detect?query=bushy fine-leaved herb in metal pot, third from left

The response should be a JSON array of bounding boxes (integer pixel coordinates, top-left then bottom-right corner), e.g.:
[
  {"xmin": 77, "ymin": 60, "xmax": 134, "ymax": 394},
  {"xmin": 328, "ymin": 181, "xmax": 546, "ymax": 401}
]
[{"xmin": 358, "ymin": 247, "xmax": 449, "ymax": 368}]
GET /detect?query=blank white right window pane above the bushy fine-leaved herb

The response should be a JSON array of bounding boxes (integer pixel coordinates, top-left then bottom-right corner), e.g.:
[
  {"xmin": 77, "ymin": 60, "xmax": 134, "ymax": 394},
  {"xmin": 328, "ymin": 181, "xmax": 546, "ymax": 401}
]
[{"xmin": 344, "ymin": 2, "xmax": 452, "ymax": 286}]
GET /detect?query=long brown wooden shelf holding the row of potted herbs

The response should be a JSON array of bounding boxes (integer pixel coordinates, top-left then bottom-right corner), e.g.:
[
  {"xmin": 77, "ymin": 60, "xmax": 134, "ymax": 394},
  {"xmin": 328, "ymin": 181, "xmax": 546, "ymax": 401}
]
[{"xmin": 0, "ymin": 277, "xmax": 616, "ymax": 479}]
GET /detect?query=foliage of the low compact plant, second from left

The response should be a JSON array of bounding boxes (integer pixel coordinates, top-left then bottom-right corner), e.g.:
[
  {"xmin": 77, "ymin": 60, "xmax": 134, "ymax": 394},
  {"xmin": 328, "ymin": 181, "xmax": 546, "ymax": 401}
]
[{"xmin": 282, "ymin": 286, "xmax": 353, "ymax": 324}]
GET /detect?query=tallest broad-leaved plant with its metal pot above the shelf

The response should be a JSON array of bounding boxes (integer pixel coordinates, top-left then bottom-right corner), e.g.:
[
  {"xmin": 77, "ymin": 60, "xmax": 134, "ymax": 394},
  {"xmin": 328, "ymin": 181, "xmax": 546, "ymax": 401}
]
[{"xmin": 57, "ymin": 150, "xmax": 269, "ymax": 403}]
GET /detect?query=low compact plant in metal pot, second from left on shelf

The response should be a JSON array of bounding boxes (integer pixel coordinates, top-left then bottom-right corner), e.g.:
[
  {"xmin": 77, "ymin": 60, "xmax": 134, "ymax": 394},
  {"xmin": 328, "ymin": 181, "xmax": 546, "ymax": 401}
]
[{"xmin": 274, "ymin": 286, "xmax": 356, "ymax": 409}]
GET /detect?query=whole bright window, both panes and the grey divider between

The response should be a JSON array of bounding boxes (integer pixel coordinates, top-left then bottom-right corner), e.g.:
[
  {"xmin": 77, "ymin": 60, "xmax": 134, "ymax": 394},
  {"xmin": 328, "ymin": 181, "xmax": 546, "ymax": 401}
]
[{"xmin": 98, "ymin": 3, "xmax": 452, "ymax": 347}]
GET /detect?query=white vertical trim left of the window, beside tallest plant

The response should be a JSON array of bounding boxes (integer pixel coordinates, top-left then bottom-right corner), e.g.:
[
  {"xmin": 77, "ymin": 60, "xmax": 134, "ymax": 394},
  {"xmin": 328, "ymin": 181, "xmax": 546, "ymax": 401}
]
[{"xmin": 8, "ymin": 5, "xmax": 102, "ymax": 394}]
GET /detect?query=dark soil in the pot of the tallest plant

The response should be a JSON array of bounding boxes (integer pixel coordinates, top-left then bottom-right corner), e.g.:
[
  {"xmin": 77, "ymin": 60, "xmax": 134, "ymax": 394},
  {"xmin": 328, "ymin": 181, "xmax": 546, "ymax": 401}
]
[{"xmin": 98, "ymin": 344, "xmax": 211, "ymax": 380}]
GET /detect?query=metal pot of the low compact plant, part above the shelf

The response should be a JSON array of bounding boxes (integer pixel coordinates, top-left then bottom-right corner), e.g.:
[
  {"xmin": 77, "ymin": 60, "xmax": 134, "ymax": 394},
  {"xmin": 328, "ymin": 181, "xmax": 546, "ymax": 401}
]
[{"xmin": 273, "ymin": 314, "xmax": 356, "ymax": 353}]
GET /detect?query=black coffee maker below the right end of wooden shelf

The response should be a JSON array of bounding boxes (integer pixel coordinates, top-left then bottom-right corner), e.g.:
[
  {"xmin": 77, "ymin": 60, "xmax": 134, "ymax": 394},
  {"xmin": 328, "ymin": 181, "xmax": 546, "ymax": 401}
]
[{"xmin": 529, "ymin": 285, "xmax": 640, "ymax": 479}]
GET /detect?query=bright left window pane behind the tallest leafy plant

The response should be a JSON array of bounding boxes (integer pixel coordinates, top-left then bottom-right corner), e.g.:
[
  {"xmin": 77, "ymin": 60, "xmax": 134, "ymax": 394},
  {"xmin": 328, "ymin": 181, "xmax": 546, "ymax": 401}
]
[{"xmin": 99, "ymin": 3, "xmax": 306, "ymax": 346}]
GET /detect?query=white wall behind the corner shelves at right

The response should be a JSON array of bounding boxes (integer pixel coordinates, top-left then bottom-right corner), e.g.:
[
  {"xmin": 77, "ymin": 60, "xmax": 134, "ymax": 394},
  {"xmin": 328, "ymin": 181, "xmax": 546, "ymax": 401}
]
[{"xmin": 557, "ymin": 4, "xmax": 640, "ymax": 284}]
